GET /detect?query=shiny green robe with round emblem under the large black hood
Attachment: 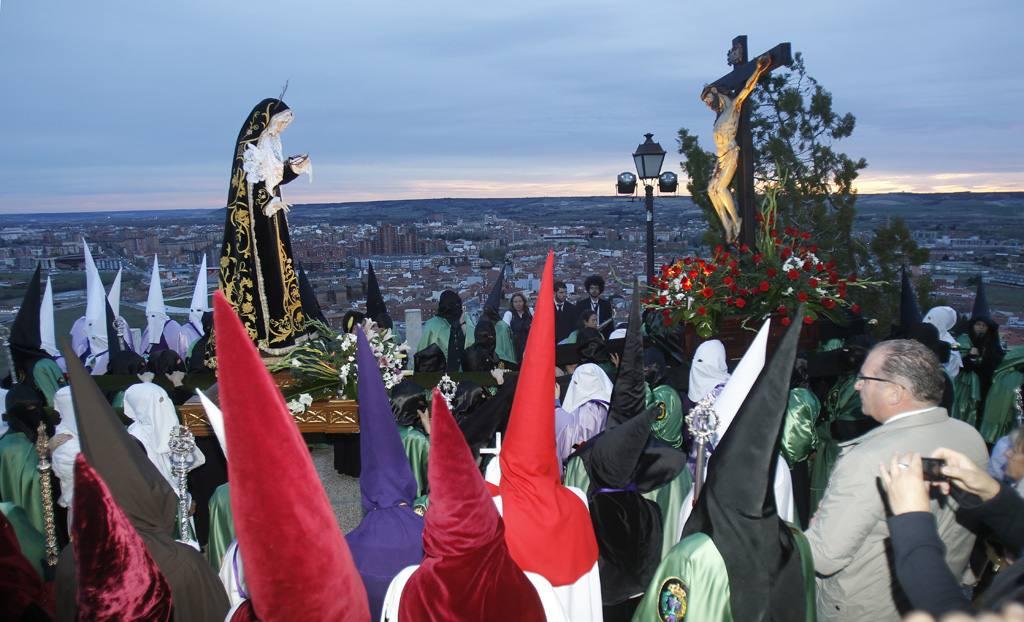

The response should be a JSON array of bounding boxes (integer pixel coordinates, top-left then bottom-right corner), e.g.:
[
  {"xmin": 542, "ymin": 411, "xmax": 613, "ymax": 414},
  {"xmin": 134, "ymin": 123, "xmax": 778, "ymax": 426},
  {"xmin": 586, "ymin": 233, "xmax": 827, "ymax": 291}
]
[{"xmin": 633, "ymin": 527, "xmax": 816, "ymax": 622}]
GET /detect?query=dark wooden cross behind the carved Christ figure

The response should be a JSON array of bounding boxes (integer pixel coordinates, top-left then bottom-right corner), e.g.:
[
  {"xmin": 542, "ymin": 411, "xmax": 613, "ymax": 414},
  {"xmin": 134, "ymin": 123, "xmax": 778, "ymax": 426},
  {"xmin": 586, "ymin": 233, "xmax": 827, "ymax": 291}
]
[{"xmin": 709, "ymin": 35, "xmax": 793, "ymax": 246}]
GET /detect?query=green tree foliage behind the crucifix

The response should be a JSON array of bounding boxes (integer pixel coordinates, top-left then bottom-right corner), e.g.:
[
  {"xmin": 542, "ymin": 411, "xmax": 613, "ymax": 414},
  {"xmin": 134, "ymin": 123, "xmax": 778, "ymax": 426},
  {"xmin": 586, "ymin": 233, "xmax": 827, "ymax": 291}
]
[{"xmin": 678, "ymin": 52, "xmax": 867, "ymax": 272}]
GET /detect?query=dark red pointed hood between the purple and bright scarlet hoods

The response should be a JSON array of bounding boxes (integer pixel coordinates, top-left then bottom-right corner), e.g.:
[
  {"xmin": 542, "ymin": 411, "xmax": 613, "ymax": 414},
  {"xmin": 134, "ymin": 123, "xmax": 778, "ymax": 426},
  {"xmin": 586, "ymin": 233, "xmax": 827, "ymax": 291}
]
[{"xmin": 398, "ymin": 389, "xmax": 554, "ymax": 622}]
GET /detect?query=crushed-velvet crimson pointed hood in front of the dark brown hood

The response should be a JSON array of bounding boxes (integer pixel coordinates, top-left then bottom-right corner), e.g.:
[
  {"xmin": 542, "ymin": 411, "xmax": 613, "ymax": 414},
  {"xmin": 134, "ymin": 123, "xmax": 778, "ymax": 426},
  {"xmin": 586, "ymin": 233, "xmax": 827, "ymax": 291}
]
[{"xmin": 72, "ymin": 454, "xmax": 171, "ymax": 622}]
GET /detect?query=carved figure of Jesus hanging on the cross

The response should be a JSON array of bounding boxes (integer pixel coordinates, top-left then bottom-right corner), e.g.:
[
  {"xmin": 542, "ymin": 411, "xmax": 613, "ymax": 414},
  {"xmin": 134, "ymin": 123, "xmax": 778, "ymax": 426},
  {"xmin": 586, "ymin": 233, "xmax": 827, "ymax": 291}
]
[{"xmin": 700, "ymin": 54, "xmax": 771, "ymax": 243}]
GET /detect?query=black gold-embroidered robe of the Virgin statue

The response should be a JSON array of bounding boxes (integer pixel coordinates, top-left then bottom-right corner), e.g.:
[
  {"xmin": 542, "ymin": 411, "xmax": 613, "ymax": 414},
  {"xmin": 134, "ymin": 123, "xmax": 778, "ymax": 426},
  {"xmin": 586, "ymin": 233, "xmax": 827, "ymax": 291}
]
[{"xmin": 220, "ymin": 99, "xmax": 305, "ymax": 355}]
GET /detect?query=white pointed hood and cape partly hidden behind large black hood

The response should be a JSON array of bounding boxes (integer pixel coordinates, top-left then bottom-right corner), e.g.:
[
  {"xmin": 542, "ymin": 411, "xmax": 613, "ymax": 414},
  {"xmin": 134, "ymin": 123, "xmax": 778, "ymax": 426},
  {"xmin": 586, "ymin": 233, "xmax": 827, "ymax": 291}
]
[{"xmin": 679, "ymin": 319, "xmax": 797, "ymax": 536}]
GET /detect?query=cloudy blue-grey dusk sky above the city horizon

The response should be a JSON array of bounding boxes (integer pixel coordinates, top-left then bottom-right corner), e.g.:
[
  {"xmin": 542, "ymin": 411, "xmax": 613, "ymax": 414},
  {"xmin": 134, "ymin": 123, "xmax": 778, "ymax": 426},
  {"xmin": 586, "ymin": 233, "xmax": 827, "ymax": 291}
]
[{"xmin": 0, "ymin": 0, "xmax": 1024, "ymax": 213}]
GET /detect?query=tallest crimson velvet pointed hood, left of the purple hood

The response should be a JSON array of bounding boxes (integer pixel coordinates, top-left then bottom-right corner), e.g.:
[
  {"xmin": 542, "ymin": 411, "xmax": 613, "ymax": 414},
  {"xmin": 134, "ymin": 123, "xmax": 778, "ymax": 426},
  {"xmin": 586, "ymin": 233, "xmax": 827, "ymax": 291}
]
[{"xmin": 213, "ymin": 291, "xmax": 370, "ymax": 622}]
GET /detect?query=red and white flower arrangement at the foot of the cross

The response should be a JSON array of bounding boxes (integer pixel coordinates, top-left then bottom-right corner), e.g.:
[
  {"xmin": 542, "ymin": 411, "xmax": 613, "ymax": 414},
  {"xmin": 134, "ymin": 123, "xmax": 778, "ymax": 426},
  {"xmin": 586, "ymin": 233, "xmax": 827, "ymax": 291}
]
[{"xmin": 644, "ymin": 189, "xmax": 882, "ymax": 339}]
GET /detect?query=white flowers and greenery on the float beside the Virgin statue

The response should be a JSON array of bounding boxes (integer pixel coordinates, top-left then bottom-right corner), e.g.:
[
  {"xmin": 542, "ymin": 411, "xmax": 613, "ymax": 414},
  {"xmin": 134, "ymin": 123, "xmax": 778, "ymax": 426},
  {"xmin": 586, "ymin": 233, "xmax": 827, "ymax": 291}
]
[{"xmin": 270, "ymin": 319, "xmax": 409, "ymax": 414}]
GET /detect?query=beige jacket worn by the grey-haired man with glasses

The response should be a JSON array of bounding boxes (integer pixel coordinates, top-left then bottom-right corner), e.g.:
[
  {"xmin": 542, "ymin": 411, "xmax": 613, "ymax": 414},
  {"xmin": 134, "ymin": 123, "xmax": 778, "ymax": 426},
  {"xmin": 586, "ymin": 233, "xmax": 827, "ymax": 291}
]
[{"xmin": 806, "ymin": 407, "xmax": 988, "ymax": 621}]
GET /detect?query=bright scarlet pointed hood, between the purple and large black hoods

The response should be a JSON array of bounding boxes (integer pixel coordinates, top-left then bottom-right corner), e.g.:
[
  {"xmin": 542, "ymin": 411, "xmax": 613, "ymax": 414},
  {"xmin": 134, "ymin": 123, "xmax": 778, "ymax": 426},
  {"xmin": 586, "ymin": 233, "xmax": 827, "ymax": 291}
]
[{"xmin": 499, "ymin": 252, "xmax": 597, "ymax": 586}]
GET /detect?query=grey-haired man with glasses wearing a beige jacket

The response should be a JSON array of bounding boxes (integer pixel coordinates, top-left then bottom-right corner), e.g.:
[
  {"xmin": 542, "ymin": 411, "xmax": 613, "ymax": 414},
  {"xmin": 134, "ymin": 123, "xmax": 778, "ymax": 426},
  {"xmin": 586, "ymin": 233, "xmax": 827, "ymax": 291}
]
[{"xmin": 806, "ymin": 339, "xmax": 987, "ymax": 621}]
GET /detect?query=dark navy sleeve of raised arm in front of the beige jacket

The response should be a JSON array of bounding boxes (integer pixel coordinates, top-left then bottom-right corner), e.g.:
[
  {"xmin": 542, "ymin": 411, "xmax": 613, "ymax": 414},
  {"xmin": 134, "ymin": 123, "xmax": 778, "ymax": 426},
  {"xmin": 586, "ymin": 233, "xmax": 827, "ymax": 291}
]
[{"xmin": 889, "ymin": 512, "xmax": 972, "ymax": 619}]
